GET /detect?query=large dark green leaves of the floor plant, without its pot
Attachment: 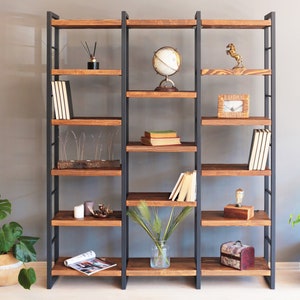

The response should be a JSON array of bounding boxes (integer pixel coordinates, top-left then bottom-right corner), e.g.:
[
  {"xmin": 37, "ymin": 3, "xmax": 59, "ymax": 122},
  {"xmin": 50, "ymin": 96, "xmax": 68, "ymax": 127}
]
[{"xmin": 0, "ymin": 199, "xmax": 39, "ymax": 289}]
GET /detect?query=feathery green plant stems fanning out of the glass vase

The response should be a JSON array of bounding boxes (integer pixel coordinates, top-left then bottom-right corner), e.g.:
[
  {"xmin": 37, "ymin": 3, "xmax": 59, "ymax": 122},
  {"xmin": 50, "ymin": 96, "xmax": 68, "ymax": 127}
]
[{"xmin": 127, "ymin": 201, "xmax": 192, "ymax": 253}]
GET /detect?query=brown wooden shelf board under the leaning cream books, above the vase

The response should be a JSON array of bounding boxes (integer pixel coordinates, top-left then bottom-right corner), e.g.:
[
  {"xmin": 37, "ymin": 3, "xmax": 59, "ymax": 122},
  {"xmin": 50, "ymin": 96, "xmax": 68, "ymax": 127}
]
[{"xmin": 126, "ymin": 192, "xmax": 197, "ymax": 207}]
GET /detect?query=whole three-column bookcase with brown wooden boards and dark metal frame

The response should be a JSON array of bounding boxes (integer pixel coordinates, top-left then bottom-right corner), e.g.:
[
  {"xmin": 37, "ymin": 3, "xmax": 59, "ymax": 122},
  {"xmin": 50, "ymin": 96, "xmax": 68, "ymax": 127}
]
[{"xmin": 47, "ymin": 12, "xmax": 276, "ymax": 289}]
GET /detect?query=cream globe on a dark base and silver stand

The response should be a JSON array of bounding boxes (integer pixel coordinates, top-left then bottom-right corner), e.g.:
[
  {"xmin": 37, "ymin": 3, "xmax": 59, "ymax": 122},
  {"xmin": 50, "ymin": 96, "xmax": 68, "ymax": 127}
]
[{"xmin": 152, "ymin": 46, "xmax": 181, "ymax": 91}]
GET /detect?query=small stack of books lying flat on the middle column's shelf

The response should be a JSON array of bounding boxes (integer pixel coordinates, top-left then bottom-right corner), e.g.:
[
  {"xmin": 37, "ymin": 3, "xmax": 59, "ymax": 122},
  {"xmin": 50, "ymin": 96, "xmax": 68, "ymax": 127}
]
[{"xmin": 141, "ymin": 130, "xmax": 181, "ymax": 146}]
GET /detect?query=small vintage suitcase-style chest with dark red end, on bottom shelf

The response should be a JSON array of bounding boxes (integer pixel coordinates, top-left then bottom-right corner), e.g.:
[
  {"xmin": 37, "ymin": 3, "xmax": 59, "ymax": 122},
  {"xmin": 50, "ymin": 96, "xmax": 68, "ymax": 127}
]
[{"xmin": 220, "ymin": 241, "xmax": 254, "ymax": 270}]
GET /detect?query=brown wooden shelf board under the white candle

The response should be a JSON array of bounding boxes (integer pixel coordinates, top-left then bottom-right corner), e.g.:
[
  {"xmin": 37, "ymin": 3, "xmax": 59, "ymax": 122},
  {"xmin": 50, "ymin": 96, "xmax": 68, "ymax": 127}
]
[{"xmin": 51, "ymin": 210, "xmax": 122, "ymax": 227}]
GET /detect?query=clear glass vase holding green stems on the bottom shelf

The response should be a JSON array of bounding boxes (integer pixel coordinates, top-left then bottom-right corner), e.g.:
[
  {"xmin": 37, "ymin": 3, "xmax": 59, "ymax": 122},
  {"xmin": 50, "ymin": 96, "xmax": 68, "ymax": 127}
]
[{"xmin": 150, "ymin": 241, "xmax": 170, "ymax": 269}]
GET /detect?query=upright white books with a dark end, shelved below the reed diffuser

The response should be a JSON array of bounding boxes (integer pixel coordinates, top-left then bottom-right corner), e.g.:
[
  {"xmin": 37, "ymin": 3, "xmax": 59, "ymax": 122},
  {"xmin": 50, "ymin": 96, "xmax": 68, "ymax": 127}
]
[{"xmin": 51, "ymin": 80, "xmax": 73, "ymax": 120}]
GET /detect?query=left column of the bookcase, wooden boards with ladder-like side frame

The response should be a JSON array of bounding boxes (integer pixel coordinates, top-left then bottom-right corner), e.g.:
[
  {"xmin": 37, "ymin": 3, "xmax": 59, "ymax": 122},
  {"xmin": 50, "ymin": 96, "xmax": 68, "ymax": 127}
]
[{"xmin": 47, "ymin": 12, "xmax": 122, "ymax": 288}]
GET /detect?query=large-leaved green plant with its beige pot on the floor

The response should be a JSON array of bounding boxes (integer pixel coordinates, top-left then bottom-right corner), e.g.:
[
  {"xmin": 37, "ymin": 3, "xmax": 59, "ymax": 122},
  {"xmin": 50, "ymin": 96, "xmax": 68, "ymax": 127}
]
[{"xmin": 0, "ymin": 199, "xmax": 39, "ymax": 289}]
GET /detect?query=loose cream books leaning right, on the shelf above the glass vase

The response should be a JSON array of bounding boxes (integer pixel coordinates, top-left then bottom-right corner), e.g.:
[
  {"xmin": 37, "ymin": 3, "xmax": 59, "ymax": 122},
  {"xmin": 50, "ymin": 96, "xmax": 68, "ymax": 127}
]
[{"xmin": 169, "ymin": 170, "xmax": 197, "ymax": 201}]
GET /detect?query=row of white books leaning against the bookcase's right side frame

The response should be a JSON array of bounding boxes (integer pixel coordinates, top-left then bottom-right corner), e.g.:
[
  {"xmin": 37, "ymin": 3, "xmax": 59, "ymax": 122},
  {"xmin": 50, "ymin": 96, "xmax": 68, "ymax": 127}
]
[{"xmin": 248, "ymin": 129, "xmax": 271, "ymax": 170}]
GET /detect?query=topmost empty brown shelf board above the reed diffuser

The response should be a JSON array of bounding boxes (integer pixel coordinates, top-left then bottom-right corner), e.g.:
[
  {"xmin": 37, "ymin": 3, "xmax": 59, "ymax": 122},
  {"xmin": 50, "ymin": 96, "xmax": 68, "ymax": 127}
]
[{"xmin": 51, "ymin": 19, "xmax": 122, "ymax": 29}]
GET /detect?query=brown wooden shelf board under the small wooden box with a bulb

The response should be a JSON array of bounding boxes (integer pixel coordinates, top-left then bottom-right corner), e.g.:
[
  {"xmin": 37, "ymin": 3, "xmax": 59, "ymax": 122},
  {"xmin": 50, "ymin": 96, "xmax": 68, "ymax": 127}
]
[{"xmin": 201, "ymin": 210, "xmax": 271, "ymax": 227}]
